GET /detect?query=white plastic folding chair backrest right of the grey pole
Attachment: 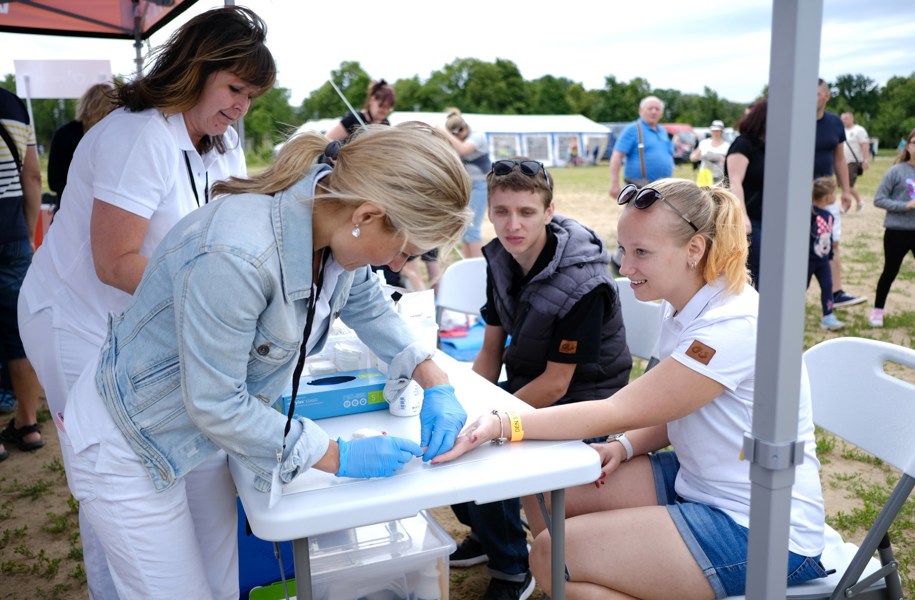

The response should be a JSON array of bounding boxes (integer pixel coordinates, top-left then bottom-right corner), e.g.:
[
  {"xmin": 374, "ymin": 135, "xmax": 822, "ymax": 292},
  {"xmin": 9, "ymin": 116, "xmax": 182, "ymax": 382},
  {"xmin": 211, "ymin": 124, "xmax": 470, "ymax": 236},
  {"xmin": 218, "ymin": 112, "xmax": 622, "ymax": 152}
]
[{"xmin": 804, "ymin": 337, "xmax": 915, "ymax": 476}]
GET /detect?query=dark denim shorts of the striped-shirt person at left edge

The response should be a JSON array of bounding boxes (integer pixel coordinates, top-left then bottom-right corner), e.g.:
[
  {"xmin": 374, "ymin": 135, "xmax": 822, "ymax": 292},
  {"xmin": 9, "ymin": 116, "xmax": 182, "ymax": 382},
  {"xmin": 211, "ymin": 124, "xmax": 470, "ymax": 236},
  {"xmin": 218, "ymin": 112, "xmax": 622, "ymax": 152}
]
[{"xmin": 0, "ymin": 239, "xmax": 32, "ymax": 362}]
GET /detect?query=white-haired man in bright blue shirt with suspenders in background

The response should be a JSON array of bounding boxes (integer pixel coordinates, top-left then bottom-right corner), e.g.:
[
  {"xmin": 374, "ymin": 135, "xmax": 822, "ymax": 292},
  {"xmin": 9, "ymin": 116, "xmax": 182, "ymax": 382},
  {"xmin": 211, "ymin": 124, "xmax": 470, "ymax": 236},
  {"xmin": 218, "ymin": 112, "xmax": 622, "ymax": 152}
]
[{"xmin": 610, "ymin": 96, "xmax": 672, "ymax": 199}]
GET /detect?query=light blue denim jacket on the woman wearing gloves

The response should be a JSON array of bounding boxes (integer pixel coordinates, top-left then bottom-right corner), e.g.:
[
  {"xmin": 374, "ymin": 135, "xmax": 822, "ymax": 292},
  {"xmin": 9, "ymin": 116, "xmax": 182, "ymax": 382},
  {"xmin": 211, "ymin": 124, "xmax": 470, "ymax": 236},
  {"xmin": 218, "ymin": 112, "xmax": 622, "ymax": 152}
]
[{"xmin": 96, "ymin": 165, "xmax": 432, "ymax": 491}]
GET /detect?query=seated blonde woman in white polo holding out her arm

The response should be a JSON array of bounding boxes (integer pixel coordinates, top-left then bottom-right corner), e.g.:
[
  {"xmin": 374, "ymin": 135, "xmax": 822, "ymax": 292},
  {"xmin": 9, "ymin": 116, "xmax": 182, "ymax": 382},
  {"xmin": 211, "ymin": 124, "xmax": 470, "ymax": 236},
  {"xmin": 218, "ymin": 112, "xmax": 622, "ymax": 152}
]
[{"xmin": 435, "ymin": 179, "xmax": 826, "ymax": 600}]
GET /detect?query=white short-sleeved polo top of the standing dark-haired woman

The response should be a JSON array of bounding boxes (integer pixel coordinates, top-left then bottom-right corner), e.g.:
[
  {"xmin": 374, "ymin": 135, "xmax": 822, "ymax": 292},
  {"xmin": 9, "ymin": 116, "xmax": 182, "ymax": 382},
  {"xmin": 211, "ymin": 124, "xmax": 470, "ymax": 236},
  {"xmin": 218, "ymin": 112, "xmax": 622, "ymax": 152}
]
[{"xmin": 22, "ymin": 109, "xmax": 245, "ymax": 346}]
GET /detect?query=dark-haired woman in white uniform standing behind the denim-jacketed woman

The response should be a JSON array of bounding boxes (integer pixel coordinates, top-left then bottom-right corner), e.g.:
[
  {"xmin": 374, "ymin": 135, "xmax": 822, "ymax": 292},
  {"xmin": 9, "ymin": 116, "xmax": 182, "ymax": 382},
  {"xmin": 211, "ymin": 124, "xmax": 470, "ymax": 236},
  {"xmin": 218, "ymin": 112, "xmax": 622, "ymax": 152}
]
[{"xmin": 19, "ymin": 7, "xmax": 276, "ymax": 598}]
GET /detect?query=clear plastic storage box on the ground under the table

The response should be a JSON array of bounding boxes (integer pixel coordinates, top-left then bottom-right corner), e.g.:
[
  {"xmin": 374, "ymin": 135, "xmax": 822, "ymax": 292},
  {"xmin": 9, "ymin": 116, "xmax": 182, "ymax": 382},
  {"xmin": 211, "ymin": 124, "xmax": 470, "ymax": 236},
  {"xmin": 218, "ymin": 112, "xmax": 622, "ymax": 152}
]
[{"xmin": 249, "ymin": 511, "xmax": 455, "ymax": 600}]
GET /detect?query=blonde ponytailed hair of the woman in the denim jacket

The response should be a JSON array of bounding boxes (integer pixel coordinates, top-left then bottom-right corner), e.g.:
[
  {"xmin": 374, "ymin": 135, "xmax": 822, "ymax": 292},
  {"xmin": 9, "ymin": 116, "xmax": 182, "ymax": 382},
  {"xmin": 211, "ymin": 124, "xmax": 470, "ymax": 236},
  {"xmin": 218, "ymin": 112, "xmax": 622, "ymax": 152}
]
[{"xmin": 213, "ymin": 121, "xmax": 471, "ymax": 253}]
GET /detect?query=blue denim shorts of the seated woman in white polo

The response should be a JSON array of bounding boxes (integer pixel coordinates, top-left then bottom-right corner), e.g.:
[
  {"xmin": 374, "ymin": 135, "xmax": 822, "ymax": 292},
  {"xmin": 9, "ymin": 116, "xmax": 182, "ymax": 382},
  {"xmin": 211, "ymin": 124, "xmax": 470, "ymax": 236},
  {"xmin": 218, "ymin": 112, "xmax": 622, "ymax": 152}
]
[{"xmin": 650, "ymin": 452, "xmax": 826, "ymax": 598}]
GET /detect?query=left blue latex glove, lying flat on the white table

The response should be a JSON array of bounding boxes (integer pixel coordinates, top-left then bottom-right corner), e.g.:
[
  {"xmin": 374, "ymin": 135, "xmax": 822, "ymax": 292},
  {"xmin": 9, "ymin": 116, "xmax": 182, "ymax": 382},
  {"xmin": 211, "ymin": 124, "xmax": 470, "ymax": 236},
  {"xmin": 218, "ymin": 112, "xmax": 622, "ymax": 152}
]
[{"xmin": 337, "ymin": 435, "xmax": 423, "ymax": 479}]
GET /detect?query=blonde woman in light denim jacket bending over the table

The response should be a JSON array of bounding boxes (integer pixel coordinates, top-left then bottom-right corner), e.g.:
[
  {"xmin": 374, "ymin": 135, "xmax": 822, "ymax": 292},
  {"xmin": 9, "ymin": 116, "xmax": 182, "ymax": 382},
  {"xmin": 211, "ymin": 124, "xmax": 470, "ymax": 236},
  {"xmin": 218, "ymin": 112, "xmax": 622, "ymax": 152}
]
[{"xmin": 62, "ymin": 124, "xmax": 470, "ymax": 598}]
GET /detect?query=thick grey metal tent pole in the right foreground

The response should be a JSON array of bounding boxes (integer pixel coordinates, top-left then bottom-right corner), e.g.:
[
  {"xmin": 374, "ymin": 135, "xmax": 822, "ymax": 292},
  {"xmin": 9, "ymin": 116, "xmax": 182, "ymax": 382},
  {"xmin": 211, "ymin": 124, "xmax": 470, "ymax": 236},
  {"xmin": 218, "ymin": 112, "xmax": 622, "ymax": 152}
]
[{"xmin": 744, "ymin": 0, "xmax": 823, "ymax": 600}]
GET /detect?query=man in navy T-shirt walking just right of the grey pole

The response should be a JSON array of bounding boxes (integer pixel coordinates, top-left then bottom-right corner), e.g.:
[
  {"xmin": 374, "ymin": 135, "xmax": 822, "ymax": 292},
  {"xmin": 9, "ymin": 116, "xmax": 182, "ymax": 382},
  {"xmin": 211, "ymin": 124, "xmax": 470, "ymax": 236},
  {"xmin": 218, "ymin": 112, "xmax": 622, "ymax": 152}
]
[{"xmin": 813, "ymin": 79, "xmax": 865, "ymax": 308}]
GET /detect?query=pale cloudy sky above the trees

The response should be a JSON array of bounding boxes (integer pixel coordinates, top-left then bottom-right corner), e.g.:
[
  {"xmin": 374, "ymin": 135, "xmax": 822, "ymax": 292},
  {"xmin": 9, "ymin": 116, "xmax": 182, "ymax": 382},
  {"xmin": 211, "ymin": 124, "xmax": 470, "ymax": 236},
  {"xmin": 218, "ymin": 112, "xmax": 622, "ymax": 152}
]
[{"xmin": 0, "ymin": 0, "xmax": 915, "ymax": 105}]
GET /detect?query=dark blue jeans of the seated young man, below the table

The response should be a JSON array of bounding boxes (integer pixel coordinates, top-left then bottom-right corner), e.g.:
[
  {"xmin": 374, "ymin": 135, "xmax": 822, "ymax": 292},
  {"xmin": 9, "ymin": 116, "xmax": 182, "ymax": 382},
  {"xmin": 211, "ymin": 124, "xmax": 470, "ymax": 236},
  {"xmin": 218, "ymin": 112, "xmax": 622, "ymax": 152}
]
[{"xmin": 451, "ymin": 498, "xmax": 530, "ymax": 581}]
